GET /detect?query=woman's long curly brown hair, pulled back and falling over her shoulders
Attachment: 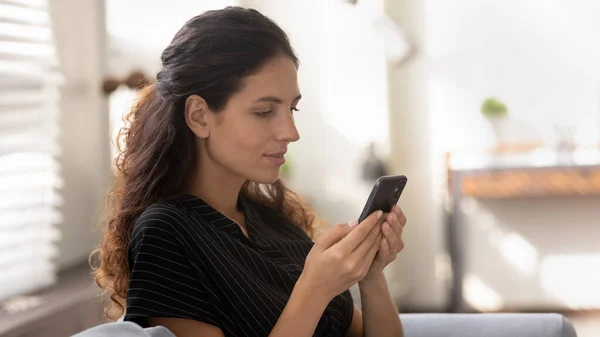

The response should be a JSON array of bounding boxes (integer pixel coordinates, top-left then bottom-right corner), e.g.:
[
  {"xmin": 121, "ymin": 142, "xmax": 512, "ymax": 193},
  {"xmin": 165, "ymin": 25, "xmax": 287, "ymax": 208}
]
[{"xmin": 90, "ymin": 7, "xmax": 328, "ymax": 320}]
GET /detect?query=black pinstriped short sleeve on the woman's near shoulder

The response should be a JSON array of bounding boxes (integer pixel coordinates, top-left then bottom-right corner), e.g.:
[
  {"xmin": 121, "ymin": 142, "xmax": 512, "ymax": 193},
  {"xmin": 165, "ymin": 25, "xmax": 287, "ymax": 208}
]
[{"xmin": 124, "ymin": 206, "xmax": 220, "ymax": 327}]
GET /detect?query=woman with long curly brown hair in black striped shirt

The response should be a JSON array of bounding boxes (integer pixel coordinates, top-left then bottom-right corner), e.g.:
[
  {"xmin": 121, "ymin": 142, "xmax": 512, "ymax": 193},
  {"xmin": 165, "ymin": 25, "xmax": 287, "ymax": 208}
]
[{"xmin": 92, "ymin": 7, "xmax": 406, "ymax": 337}]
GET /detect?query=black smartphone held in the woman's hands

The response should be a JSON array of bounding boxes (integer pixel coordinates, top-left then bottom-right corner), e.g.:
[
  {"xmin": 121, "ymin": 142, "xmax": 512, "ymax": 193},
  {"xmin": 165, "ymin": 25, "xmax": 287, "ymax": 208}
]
[{"xmin": 358, "ymin": 175, "xmax": 408, "ymax": 223}]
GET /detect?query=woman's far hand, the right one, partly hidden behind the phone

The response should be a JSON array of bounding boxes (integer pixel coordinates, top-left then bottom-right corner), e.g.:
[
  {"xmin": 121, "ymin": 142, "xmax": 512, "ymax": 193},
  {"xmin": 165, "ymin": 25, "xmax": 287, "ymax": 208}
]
[{"xmin": 363, "ymin": 205, "xmax": 406, "ymax": 281}]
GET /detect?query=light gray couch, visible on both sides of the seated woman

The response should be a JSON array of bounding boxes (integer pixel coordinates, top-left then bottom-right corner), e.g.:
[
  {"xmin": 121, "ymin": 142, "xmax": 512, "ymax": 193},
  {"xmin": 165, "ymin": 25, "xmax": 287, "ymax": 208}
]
[{"xmin": 74, "ymin": 314, "xmax": 577, "ymax": 337}]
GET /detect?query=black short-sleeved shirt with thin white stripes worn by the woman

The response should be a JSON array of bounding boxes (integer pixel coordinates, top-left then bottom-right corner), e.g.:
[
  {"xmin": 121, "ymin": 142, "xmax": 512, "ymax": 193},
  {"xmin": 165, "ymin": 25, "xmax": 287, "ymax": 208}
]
[{"xmin": 125, "ymin": 195, "xmax": 354, "ymax": 337}]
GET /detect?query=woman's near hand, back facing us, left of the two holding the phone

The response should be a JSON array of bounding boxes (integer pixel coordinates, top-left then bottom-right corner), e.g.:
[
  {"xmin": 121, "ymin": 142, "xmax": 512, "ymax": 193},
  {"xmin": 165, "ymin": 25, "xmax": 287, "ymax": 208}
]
[{"xmin": 299, "ymin": 211, "xmax": 383, "ymax": 300}]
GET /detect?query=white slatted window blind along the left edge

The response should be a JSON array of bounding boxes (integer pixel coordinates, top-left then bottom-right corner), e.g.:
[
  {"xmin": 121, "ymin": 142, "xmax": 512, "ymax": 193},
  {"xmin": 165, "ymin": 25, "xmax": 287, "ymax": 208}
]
[{"xmin": 0, "ymin": 0, "xmax": 62, "ymax": 301}]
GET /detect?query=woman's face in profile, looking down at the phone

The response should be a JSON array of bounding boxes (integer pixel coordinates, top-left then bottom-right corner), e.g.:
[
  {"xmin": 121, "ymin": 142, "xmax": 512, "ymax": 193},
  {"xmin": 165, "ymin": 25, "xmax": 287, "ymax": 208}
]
[{"xmin": 191, "ymin": 57, "xmax": 300, "ymax": 184}]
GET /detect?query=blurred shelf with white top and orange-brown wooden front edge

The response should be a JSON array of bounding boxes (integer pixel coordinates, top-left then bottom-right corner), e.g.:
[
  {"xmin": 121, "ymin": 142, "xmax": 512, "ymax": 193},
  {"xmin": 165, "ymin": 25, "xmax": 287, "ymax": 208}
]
[{"xmin": 448, "ymin": 148, "xmax": 600, "ymax": 198}]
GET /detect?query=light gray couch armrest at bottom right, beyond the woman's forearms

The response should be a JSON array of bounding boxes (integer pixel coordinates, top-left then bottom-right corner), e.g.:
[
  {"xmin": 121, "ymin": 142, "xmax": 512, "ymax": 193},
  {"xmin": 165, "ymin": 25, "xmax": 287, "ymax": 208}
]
[{"xmin": 400, "ymin": 314, "xmax": 577, "ymax": 337}]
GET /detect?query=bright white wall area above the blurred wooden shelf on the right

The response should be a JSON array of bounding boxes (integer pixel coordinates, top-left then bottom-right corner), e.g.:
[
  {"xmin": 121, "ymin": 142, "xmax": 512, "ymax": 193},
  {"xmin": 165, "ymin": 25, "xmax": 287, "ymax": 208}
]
[{"xmin": 426, "ymin": 0, "xmax": 600, "ymax": 149}]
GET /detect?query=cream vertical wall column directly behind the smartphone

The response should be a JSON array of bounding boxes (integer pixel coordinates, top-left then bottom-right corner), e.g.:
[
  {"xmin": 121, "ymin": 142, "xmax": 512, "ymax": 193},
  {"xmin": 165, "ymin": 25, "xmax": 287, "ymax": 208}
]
[{"xmin": 385, "ymin": 0, "xmax": 449, "ymax": 311}]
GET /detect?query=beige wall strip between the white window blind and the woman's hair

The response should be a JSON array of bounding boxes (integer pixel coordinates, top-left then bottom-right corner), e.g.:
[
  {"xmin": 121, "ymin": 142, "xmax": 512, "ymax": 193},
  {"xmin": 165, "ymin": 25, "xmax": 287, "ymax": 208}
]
[{"xmin": 49, "ymin": 0, "xmax": 110, "ymax": 269}]
